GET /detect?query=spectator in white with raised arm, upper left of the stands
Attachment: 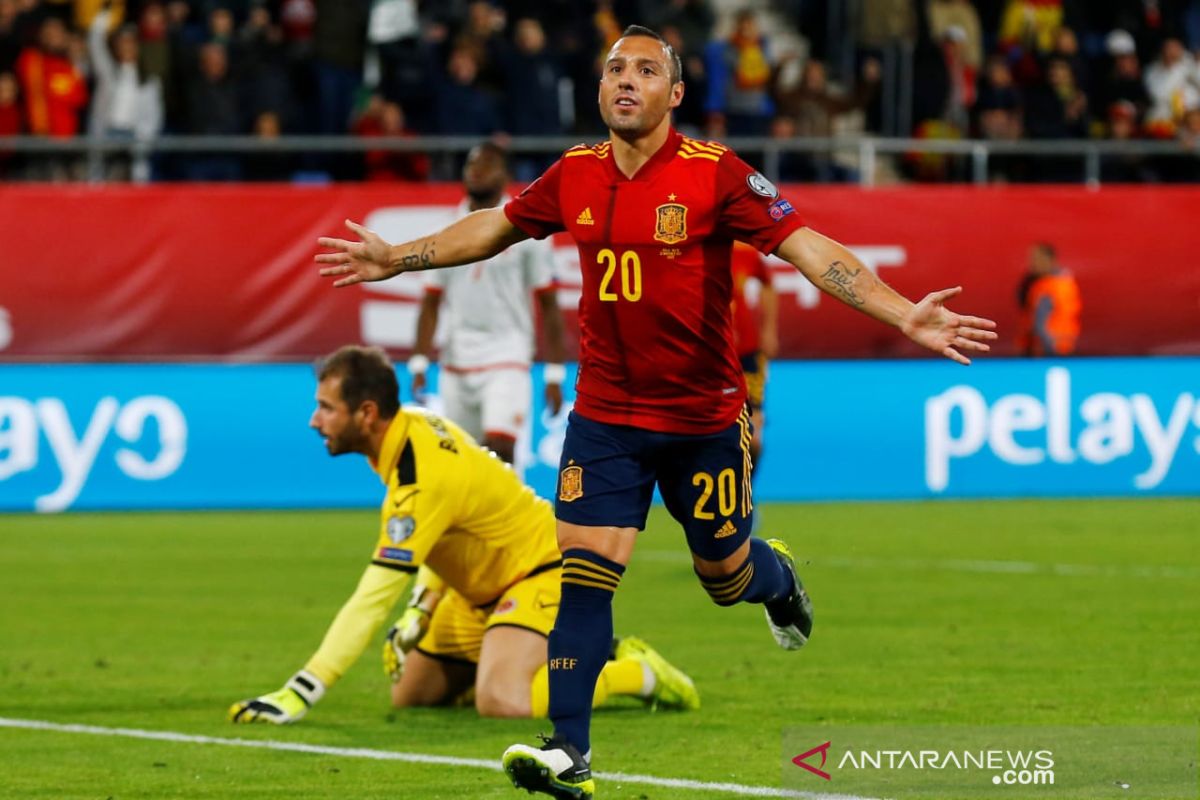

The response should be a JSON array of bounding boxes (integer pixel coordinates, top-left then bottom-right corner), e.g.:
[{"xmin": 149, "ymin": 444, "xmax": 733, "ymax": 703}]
[{"xmin": 88, "ymin": 10, "xmax": 163, "ymax": 181}]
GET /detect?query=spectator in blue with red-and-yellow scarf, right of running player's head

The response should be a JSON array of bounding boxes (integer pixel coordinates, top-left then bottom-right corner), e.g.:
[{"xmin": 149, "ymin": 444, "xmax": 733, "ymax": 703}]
[{"xmin": 704, "ymin": 8, "xmax": 775, "ymax": 138}]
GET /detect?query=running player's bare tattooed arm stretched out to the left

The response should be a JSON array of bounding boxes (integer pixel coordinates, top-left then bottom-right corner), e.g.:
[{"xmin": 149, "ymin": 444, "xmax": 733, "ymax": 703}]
[{"xmin": 316, "ymin": 207, "xmax": 528, "ymax": 287}]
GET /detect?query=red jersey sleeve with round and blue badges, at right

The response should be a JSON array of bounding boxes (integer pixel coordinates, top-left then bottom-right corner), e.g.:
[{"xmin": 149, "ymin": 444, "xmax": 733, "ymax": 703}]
[{"xmin": 716, "ymin": 151, "xmax": 804, "ymax": 254}]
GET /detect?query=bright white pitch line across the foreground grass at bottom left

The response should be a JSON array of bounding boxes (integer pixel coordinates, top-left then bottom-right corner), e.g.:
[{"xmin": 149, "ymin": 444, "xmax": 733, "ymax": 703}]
[{"xmin": 0, "ymin": 717, "xmax": 872, "ymax": 800}]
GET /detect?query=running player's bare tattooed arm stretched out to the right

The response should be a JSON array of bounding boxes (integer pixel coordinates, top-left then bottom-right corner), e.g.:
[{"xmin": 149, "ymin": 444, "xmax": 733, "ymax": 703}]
[{"xmin": 775, "ymin": 228, "xmax": 996, "ymax": 365}]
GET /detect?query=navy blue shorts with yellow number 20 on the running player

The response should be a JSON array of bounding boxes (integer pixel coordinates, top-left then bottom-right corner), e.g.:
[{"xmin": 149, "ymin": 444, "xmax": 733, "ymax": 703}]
[{"xmin": 554, "ymin": 410, "xmax": 754, "ymax": 561}]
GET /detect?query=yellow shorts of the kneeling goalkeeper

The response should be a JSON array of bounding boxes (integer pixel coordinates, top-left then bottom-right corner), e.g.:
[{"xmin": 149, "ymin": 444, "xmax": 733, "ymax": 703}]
[{"xmin": 416, "ymin": 563, "xmax": 563, "ymax": 664}]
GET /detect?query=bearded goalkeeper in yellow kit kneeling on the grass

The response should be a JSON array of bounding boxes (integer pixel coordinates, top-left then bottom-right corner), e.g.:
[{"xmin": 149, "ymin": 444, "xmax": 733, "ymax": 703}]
[{"xmin": 229, "ymin": 347, "xmax": 700, "ymax": 723}]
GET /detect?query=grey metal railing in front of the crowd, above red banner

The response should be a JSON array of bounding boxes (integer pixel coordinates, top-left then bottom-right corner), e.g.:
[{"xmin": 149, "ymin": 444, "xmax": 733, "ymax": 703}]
[{"xmin": 0, "ymin": 136, "xmax": 1200, "ymax": 186}]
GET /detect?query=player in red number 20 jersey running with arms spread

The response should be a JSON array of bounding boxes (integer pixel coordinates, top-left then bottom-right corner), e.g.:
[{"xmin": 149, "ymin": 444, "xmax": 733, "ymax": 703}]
[{"xmin": 317, "ymin": 26, "xmax": 996, "ymax": 799}]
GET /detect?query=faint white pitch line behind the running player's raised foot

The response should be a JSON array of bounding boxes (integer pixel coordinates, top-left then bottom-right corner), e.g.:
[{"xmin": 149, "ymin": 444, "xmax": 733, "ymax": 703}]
[{"xmin": 634, "ymin": 551, "xmax": 1200, "ymax": 578}]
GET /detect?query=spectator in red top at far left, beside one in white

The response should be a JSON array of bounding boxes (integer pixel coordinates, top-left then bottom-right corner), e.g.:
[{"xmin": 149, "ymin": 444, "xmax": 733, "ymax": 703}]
[{"xmin": 17, "ymin": 17, "xmax": 88, "ymax": 137}]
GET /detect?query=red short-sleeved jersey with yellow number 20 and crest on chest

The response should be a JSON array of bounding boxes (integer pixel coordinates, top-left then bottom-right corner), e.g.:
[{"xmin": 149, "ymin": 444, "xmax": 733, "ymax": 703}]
[{"xmin": 504, "ymin": 131, "xmax": 804, "ymax": 433}]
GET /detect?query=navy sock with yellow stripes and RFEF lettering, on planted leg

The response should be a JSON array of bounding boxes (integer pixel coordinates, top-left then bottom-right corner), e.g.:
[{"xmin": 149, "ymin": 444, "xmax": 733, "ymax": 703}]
[{"xmin": 548, "ymin": 548, "xmax": 625, "ymax": 753}]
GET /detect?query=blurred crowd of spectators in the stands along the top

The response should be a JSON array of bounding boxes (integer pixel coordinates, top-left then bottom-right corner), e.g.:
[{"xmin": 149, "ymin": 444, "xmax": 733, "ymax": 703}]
[{"xmin": 0, "ymin": 0, "xmax": 1200, "ymax": 181}]
